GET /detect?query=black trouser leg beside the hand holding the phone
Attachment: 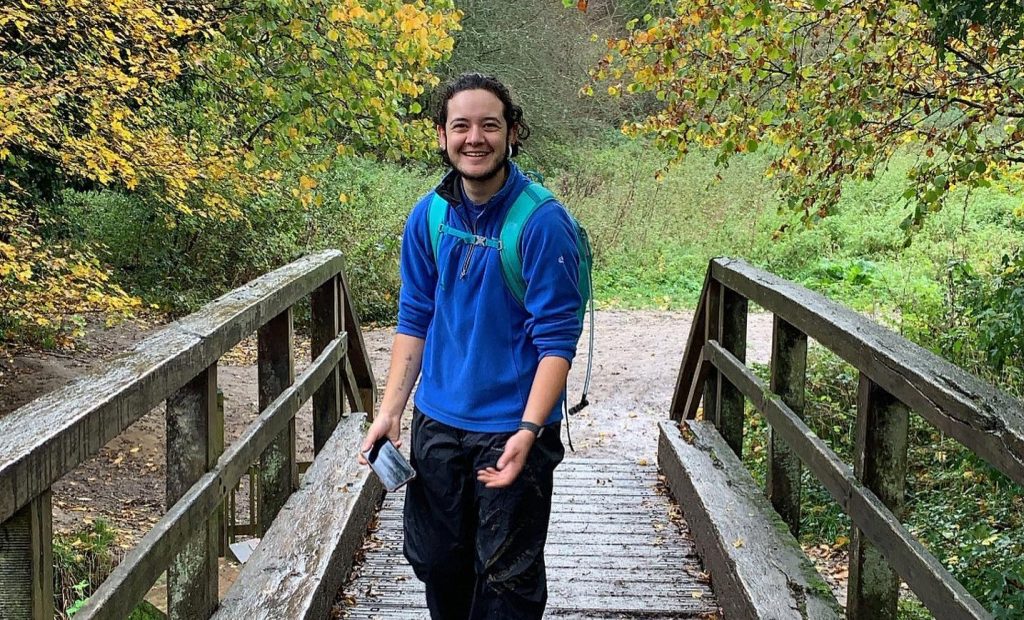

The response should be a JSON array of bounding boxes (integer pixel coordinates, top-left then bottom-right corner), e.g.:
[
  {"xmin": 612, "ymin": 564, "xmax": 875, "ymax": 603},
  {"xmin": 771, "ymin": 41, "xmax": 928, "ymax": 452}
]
[{"xmin": 404, "ymin": 410, "xmax": 476, "ymax": 620}]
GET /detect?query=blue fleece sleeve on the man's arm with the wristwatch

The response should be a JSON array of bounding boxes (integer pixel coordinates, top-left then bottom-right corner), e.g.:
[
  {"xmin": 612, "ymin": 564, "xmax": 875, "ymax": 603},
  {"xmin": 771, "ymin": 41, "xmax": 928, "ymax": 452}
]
[{"xmin": 520, "ymin": 202, "xmax": 583, "ymax": 363}]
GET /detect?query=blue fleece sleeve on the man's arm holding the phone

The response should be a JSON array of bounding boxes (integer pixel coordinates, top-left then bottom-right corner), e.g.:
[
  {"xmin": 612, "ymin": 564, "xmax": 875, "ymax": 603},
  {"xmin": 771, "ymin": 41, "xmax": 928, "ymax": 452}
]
[{"xmin": 396, "ymin": 195, "xmax": 437, "ymax": 338}]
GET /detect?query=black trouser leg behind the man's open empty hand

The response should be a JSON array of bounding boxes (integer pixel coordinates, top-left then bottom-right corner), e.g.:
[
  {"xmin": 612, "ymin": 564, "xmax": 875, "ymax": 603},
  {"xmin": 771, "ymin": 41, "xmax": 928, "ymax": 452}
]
[{"xmin": 469, "ymin": 424, "xmax": 565, "ymax": 620}]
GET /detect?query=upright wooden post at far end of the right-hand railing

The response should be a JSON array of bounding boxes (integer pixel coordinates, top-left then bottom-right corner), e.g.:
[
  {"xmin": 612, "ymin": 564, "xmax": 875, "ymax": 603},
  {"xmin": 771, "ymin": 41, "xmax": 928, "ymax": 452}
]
[{"xmin": 715, "ymin": 285, "xmax": 746, "ymax": 456}]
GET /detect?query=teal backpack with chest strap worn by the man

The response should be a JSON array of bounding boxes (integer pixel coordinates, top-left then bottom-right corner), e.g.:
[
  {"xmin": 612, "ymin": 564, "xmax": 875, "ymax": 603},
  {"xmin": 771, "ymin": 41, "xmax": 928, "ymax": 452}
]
[{"xmin": 427, "ymin": 180, "xmax": 594, "ymax": 434}]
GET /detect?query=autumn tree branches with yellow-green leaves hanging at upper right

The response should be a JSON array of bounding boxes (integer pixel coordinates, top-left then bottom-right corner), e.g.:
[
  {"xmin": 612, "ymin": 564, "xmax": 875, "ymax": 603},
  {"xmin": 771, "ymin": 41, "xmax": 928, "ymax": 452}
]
[{"xmin": 588, "ymin": 0, "xmax": 1024, "ymax": 229}]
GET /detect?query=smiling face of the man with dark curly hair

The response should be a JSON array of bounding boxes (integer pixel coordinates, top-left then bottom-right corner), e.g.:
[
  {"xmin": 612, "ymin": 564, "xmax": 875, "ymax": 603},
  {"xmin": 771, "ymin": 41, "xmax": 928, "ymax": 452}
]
[{"xmin": 437, "ymin": 89, "xmax": 515, "ymax": 181}]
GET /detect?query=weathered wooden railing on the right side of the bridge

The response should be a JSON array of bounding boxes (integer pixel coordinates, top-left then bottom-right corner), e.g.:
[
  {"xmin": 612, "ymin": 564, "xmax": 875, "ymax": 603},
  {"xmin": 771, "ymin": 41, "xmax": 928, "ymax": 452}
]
[{"xmin": 672, "ymin": 258, "xmax": 1024, "ymax": 619}]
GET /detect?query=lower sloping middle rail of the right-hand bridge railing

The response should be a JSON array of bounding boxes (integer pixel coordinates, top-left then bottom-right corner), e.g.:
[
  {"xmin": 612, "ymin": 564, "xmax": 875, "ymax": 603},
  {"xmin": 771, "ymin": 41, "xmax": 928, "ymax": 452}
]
[{"xmin": 705, "ymin": 342, "xmax": 989, "ymax": 619}]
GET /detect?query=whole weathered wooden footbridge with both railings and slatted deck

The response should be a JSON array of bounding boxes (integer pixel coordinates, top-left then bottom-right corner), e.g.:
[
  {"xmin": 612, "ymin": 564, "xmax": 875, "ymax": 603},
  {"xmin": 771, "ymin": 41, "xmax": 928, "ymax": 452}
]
[{"xmin": 0, "ymin": 252, "xmax": 1024, "ymax": 620}]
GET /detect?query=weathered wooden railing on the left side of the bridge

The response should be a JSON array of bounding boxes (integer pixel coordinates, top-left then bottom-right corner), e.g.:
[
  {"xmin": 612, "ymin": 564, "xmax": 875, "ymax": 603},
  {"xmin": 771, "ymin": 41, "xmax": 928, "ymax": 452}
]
[{"xmin": 0, "ymin": 251, "xmax": 376, "ymax": 620}]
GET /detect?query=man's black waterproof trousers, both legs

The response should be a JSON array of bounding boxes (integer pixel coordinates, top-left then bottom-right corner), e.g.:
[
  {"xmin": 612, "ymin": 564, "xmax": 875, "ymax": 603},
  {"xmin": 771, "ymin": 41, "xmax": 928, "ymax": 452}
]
[{"xmin": 404, "ymin": 410, "xmax": 565, "ymax": 620}]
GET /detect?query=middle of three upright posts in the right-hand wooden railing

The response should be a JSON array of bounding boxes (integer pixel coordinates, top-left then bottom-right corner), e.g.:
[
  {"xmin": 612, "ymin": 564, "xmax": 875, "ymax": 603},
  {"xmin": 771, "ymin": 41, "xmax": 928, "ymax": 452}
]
[{"xmin": 765, "ymin": 315, "xmax": 807, "ymax": 537}]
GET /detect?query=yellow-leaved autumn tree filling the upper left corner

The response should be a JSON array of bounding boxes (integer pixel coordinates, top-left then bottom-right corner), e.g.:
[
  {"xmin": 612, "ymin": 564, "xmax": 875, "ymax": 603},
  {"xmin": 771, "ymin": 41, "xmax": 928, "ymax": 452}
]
[{"xmin": 0, "ymin": 0, "xmax": 459, "ymax": 342}]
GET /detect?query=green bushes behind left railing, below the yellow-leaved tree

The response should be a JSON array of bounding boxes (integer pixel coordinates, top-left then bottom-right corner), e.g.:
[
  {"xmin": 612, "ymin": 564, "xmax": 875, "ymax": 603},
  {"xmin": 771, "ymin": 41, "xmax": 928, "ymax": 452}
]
[{"xmin": 59, "ymin": 157, "xmax": 435, "ymax": 321}]
